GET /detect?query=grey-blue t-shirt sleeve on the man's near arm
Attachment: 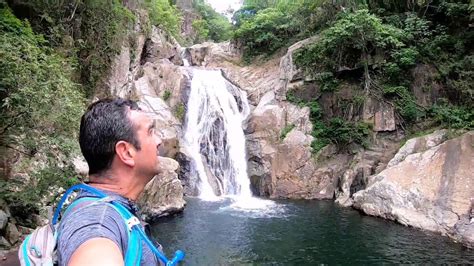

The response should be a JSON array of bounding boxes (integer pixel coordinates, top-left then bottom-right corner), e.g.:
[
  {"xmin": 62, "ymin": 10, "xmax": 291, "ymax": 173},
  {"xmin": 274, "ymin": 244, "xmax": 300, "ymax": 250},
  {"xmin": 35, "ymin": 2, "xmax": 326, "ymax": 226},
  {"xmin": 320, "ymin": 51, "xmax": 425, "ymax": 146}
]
[{"xmin": 57, "ymin": 204, "xmax": 128, "ymax": 265}]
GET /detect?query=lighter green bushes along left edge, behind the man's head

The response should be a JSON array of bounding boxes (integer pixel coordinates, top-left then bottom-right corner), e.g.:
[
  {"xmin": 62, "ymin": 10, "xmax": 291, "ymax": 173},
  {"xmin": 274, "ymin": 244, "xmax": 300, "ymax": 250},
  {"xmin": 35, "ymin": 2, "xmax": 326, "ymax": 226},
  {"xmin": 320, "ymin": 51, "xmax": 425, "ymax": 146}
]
[{"xmin": 0, "ymin": 3, "xmax": 85, "ymax": 218}]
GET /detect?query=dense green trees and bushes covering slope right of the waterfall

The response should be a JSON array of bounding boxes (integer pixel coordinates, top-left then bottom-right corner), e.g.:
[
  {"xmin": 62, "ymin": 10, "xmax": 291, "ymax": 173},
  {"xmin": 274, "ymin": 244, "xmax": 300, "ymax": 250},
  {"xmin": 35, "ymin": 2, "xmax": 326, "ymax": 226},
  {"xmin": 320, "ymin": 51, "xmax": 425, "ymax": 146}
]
[{"xmin": 234, "ymin": 0, "xmax": 474, "ymax": 151}]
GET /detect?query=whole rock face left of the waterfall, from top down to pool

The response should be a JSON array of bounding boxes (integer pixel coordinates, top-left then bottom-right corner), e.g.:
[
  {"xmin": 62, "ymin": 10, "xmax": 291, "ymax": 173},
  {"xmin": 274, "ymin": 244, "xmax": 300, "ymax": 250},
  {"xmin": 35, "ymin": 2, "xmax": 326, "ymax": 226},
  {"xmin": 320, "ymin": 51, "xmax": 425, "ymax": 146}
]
[{"xmin": 105, "ymin": 22, "xmax": 190, "ymax": 220}]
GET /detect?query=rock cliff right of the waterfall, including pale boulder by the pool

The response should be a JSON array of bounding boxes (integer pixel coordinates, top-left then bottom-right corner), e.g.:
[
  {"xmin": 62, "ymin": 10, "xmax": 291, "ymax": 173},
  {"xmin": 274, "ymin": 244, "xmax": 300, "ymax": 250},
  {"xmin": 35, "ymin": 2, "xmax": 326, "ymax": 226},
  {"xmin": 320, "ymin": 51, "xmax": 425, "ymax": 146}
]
[{"xmin": 185, "ymin": 37, "xmax": 474, "ymax": 246}]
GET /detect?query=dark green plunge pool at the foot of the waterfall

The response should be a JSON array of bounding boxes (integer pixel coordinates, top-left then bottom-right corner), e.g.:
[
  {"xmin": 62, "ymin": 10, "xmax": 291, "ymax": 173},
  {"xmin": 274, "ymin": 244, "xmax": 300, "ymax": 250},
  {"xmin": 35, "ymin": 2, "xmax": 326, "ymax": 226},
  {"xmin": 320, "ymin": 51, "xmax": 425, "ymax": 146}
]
[{"xmin": 152, "ymin": 198, "xmax": 474, "ymax": 265}]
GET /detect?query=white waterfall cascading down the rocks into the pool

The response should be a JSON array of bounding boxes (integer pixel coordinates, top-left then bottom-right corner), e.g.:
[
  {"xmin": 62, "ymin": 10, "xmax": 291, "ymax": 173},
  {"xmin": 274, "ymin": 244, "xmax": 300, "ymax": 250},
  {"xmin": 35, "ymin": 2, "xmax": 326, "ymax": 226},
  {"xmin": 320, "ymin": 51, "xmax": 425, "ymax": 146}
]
[{"xmin": 184, "ymin": 69, "xmax": 252, "ymax": 198}]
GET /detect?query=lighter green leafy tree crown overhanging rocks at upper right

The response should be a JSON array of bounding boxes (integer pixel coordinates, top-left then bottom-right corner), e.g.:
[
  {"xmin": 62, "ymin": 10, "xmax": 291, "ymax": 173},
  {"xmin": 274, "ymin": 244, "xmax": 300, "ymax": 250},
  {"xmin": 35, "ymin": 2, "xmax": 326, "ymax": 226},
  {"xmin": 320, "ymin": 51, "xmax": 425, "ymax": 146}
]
[{"xmin": 295, "ymin": 9, "xmax": 404, "ymax": 74}]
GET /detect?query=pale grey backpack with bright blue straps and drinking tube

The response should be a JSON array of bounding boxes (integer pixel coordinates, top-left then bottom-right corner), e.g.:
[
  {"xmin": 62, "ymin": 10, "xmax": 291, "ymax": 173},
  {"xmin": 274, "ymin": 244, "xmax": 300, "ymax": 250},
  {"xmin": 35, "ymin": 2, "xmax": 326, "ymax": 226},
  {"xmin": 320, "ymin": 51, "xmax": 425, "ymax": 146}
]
[{"xmin": 18, "ymin": 184, "xmax": 184, "ymax": 266}]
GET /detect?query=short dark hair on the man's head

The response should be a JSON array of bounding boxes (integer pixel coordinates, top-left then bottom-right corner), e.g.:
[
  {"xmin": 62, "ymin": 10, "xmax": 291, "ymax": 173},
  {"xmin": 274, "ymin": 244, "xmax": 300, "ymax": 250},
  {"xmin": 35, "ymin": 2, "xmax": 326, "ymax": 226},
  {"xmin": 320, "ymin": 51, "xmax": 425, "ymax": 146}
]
[{"xmin": 79, "ymin": 98, "xmax": 141, "ymax": 175}]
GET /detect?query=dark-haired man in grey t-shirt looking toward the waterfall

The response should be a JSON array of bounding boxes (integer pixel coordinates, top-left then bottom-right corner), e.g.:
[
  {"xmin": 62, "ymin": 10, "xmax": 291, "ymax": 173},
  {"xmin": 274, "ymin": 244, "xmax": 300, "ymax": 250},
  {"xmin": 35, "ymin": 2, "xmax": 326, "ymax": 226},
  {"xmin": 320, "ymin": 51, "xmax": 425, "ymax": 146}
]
[{"xmin": 58, "ymin": 99, "xmax": 161, "ymax": 266}]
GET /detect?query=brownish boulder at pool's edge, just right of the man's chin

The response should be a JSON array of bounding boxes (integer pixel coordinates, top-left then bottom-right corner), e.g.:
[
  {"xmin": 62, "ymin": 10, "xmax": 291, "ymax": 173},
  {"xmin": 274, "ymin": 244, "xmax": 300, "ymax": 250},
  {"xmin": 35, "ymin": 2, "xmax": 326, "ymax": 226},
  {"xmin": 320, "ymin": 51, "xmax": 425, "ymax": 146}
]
[{"xmin": 139, "ymin": 157, "xmax": 186, "ymax": 221}]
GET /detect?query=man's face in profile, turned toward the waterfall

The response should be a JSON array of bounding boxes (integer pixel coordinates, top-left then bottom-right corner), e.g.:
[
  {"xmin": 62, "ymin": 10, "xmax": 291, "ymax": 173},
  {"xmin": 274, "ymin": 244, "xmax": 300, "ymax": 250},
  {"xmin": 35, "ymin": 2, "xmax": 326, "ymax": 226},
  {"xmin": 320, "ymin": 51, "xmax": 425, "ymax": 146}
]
[{"xmin": 130, "ymin": 110, "xmax": 161, "ymax": 180}]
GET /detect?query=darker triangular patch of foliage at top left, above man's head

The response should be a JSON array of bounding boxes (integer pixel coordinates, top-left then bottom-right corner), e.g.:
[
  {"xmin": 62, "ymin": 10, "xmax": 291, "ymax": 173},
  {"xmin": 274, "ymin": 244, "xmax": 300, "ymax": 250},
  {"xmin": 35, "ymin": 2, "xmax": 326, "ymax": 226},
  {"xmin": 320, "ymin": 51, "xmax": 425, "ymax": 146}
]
[{"xmin": 4, "ymin": 0, "xmax": 135, "ymax": 96}]
